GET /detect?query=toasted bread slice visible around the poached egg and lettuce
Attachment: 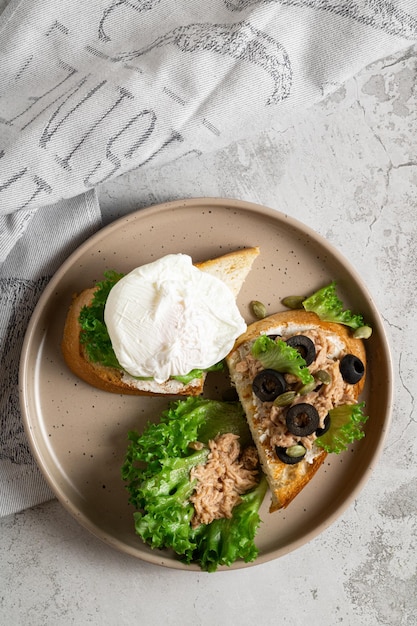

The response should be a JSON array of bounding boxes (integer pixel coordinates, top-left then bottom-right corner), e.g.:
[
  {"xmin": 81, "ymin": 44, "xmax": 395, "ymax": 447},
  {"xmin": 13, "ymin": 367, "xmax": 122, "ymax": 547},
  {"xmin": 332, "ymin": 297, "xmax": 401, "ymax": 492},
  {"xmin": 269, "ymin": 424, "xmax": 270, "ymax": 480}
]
[{"xmin": 61, "ymin": 247, "xmax": 259, "ymax": 396}]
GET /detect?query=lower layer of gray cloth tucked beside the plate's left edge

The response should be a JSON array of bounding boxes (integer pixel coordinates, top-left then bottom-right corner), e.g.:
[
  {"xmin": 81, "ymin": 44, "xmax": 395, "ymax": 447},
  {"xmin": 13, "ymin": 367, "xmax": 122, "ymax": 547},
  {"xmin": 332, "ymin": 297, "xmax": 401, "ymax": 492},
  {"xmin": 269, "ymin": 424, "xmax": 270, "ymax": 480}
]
[{"xmin": 0, "ymin": 190, "xmax": 101, "ymax": 516}]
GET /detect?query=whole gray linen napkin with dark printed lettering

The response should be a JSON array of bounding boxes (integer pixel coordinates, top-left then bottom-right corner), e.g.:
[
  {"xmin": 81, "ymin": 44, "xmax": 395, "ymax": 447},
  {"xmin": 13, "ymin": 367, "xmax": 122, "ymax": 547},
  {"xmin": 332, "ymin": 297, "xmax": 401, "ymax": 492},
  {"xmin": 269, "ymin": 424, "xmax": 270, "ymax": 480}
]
[{"xmin": 0, "ymin": 0, "xmax": 417, "ymax": 515}]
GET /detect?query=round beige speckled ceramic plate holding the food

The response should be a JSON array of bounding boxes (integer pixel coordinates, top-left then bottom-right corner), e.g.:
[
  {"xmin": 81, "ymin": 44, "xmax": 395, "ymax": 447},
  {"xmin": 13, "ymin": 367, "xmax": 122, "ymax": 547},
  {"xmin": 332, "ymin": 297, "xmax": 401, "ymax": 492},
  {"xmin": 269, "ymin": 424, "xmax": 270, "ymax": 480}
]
[{"xmin": 20, "ymin": 199, "xmax": 392, "ymax": 569}]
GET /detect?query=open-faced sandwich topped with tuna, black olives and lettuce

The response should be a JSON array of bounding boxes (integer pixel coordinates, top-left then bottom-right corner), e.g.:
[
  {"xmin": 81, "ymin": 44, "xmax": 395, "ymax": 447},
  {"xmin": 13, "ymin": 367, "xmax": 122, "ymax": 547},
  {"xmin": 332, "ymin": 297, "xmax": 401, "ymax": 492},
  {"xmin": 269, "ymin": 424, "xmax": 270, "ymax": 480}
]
[{"xmin": 226, "ymin": 283, "xmax": 370, "ymax": 512}]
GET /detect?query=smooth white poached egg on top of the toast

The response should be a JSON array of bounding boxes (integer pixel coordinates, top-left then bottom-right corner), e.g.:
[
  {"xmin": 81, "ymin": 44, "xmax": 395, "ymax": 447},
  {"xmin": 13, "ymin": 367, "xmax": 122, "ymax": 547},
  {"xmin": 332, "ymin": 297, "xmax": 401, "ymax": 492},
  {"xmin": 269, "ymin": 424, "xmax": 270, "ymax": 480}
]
[{"xmin": 104, "ymin": 254, "xmax": 246, "ymax": 383}]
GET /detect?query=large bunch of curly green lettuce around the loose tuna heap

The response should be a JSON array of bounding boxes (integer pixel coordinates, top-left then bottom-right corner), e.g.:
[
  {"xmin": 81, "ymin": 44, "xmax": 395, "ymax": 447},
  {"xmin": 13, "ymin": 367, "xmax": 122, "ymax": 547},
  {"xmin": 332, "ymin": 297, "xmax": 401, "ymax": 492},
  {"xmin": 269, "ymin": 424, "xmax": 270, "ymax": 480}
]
[{"xmin": 122, "ymin": 397, "xmax": 266, "ymax": 572}]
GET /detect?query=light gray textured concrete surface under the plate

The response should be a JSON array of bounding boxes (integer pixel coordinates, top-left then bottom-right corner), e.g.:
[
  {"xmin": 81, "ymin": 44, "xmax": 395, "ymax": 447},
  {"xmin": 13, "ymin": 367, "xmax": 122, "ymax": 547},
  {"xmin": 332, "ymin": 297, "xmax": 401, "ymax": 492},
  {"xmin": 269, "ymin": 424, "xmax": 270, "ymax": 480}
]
[{"xmin": 0, "ymin": 31, "xmax": 417, "ymax": 626}]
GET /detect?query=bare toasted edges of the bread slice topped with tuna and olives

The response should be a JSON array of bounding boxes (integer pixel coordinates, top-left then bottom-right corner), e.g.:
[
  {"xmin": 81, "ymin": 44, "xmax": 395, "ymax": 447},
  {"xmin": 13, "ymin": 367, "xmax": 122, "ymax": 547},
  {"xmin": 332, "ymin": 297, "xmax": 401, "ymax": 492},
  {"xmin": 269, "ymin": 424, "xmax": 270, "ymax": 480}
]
[{"xmin": 226, "ymin": 309, "xmax": 366, "ymax": 513}]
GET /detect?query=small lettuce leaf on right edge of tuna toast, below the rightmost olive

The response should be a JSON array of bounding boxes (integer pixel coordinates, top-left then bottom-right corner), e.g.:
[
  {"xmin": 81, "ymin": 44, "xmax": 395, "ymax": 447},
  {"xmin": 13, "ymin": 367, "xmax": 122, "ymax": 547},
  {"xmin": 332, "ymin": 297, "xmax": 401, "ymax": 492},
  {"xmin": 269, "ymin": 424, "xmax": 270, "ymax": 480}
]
[{"xmin": 315, "ymin": 402, "xmax": 368, "ymax": 454}]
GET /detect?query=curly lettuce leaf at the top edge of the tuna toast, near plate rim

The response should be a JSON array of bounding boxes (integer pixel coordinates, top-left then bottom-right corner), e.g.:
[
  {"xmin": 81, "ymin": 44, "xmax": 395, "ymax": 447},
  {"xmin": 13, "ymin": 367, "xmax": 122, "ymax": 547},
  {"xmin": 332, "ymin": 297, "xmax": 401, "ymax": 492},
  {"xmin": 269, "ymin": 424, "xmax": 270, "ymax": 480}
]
[{"xmin": 302, "ymin": 281, "xmax": 364, "ymax": 330}]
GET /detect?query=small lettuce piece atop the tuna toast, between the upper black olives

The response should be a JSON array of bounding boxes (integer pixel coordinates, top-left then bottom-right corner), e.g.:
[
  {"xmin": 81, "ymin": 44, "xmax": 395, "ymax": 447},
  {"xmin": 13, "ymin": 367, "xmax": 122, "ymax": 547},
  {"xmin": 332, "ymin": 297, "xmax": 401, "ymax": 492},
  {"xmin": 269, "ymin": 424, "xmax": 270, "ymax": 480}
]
[{"xmin": 252, "ymin": 335, "xmax": 313, "ymax": 384}]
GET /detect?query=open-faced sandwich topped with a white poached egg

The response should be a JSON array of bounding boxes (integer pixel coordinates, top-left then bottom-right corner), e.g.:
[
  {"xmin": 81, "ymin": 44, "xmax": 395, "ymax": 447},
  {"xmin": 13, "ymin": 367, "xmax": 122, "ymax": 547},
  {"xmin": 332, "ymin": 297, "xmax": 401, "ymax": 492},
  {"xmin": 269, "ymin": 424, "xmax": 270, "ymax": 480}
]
[{"xmin": 62, "ymin": 247, "xmax": 259, "ymax": 395}]
